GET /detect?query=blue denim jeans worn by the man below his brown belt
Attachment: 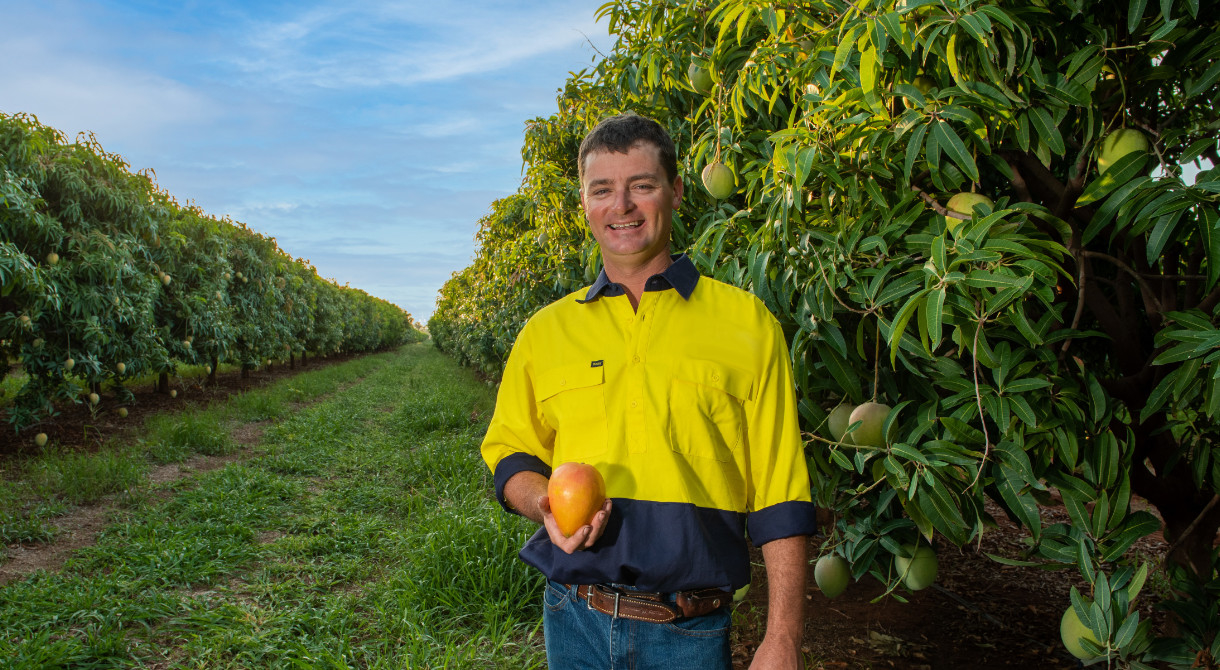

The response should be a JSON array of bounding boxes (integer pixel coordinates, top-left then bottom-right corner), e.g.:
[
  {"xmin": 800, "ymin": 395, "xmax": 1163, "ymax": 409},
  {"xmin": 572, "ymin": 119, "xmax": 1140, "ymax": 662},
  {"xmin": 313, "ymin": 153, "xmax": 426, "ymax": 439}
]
[{"xmin": 542, "ymin": 580, "xmax": 732, "ymax": 670}]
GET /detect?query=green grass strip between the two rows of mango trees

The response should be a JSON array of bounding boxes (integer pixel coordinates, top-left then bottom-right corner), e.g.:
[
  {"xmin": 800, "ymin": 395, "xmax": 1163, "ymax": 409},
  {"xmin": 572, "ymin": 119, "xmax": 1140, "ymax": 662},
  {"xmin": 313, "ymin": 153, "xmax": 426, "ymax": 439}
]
[{"xmin": 0, "ymin": 344, "xmax": 545, "ymax": 669}]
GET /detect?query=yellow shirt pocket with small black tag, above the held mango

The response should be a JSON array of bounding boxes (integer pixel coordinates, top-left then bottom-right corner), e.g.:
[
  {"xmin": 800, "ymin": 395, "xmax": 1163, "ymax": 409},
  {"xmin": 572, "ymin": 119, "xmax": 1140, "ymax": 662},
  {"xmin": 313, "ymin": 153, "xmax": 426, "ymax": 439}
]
[{"xmin": 536, "ymin": 362, "xmax": 608, "ymax": 456}]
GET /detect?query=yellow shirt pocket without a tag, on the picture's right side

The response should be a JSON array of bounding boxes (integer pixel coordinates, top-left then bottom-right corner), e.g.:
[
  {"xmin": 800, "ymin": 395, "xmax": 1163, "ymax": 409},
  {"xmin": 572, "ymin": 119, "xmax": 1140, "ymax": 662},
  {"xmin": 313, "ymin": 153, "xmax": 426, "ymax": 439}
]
[{"xmin": 669, "ymin": 360, "xmax": 752, "ymax": 461}]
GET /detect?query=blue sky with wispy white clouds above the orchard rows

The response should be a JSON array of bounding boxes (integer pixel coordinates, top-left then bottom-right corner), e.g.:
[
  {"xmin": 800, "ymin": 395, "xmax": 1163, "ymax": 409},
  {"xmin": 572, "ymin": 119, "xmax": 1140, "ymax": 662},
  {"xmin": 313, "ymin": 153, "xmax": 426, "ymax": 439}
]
[{"xmin": 0, "ymin": 0, "xmax": 611, "ymax": 320}]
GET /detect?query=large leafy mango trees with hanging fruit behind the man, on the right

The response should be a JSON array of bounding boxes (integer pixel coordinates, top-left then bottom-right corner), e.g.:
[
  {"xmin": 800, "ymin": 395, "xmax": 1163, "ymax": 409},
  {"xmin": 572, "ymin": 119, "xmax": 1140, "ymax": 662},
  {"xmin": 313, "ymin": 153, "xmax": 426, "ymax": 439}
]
[{"xmin": 429, "ymin": 0, "xmax": 1220, "ymax": 668}]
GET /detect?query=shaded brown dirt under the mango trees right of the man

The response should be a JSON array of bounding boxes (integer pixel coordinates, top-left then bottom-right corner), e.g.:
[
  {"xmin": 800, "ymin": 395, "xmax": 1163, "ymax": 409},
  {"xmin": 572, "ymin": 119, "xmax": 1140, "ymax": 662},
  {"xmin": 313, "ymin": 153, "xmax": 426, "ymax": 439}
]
[{"xmin": 733, "ymin": 506, "xmax": 1166, "ymax": 670}]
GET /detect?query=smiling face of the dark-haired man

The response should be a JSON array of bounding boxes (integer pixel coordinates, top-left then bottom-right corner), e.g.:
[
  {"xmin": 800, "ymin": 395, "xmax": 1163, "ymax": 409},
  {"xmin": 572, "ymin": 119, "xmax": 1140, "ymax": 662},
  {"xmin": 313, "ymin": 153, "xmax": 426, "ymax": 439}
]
[{"xmin": 581, "ymin": 142, "xmax": 682, "ymax": 266}]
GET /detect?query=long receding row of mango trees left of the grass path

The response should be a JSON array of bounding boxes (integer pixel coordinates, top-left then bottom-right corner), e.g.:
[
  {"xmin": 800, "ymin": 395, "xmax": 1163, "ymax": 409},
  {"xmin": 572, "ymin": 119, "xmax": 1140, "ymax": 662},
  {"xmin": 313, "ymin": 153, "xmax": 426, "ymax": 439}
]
[{"xmin": 0, "ymin": 113, "xmax": 423, "ymax": 430}]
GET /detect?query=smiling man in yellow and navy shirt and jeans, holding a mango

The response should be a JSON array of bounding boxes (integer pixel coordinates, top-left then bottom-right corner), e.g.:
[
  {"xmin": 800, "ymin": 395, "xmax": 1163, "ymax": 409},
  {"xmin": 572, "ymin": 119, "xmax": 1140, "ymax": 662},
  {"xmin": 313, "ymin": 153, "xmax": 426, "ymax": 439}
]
[{"xmin": 482, "ymin": 115, "xmax": 815, "ymax": 670}]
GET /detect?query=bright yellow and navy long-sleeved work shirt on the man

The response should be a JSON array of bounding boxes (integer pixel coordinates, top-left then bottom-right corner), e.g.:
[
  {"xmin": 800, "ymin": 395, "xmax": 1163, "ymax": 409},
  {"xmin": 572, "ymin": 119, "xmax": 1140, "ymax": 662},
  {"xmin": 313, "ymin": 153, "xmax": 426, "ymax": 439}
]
[{"xmin": 482, "ymin": 255, "xmax": 815, "ymax": 592}]
